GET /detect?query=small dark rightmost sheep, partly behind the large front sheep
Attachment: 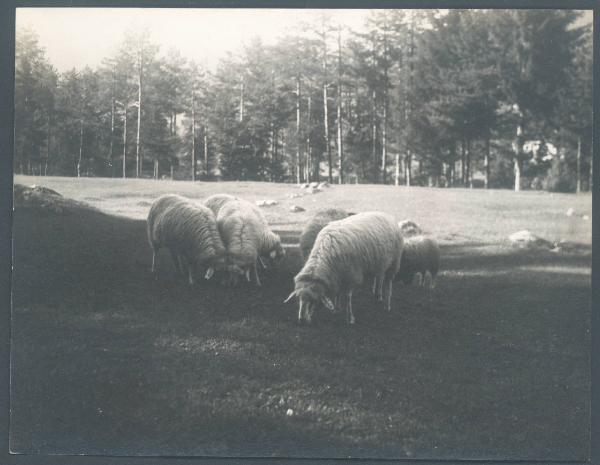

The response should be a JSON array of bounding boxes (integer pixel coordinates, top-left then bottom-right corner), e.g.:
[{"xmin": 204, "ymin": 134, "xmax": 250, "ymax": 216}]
[{"xmin": 396, "ymin": 235, "xmax": 440, "ymax": 289}]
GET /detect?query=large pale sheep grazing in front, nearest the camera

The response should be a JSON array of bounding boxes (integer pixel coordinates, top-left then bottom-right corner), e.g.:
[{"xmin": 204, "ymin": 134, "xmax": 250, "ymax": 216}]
[{"xmin": 285, "ymin": 212, "xmax": 403, "ymax": 324}]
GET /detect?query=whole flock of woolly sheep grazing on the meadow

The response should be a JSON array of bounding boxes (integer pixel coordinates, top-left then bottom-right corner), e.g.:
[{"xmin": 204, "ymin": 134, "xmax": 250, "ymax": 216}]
[{"xmin": 148, "ymin": 194, "xmax": 440, "ymax": 324}]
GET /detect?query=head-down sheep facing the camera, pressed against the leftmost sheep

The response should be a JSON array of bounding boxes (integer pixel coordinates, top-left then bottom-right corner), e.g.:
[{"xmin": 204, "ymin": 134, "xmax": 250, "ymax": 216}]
[{"xmin": 217, "ymin": 199, "xmax": 264, "ymax": 286}]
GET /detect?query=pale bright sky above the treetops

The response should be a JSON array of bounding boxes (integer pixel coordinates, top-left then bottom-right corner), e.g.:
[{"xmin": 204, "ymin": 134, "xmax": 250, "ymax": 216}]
[{"xmin": 17, "ymin": 8, "xmax": 369, "ymax": 71}]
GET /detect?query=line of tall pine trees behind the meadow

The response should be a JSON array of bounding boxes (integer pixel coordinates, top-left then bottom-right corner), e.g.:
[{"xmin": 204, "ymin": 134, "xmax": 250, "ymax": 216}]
[{"xmin": 14, "ymin": 10, "xmax": 592, "ymax": 191}]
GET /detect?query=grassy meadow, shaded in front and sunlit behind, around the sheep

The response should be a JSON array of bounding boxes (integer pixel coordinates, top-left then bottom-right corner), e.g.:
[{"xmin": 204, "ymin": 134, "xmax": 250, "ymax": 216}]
[{"xmin": 10, "ymin": 176, "xmax": 592, "ymax": 460}]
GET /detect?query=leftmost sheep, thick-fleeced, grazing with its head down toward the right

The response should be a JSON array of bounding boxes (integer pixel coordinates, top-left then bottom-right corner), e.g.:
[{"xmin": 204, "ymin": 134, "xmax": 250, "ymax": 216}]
[{"xmin": 147, "ymin": 194, "xmax": 226, "ymax": 285}]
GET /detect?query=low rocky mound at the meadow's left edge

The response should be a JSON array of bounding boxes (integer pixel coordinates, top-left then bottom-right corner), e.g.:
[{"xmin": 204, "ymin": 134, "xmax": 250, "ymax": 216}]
[{"xmin": 13, "ymin": 184, "xmax": 97, "ymax": 213}]
